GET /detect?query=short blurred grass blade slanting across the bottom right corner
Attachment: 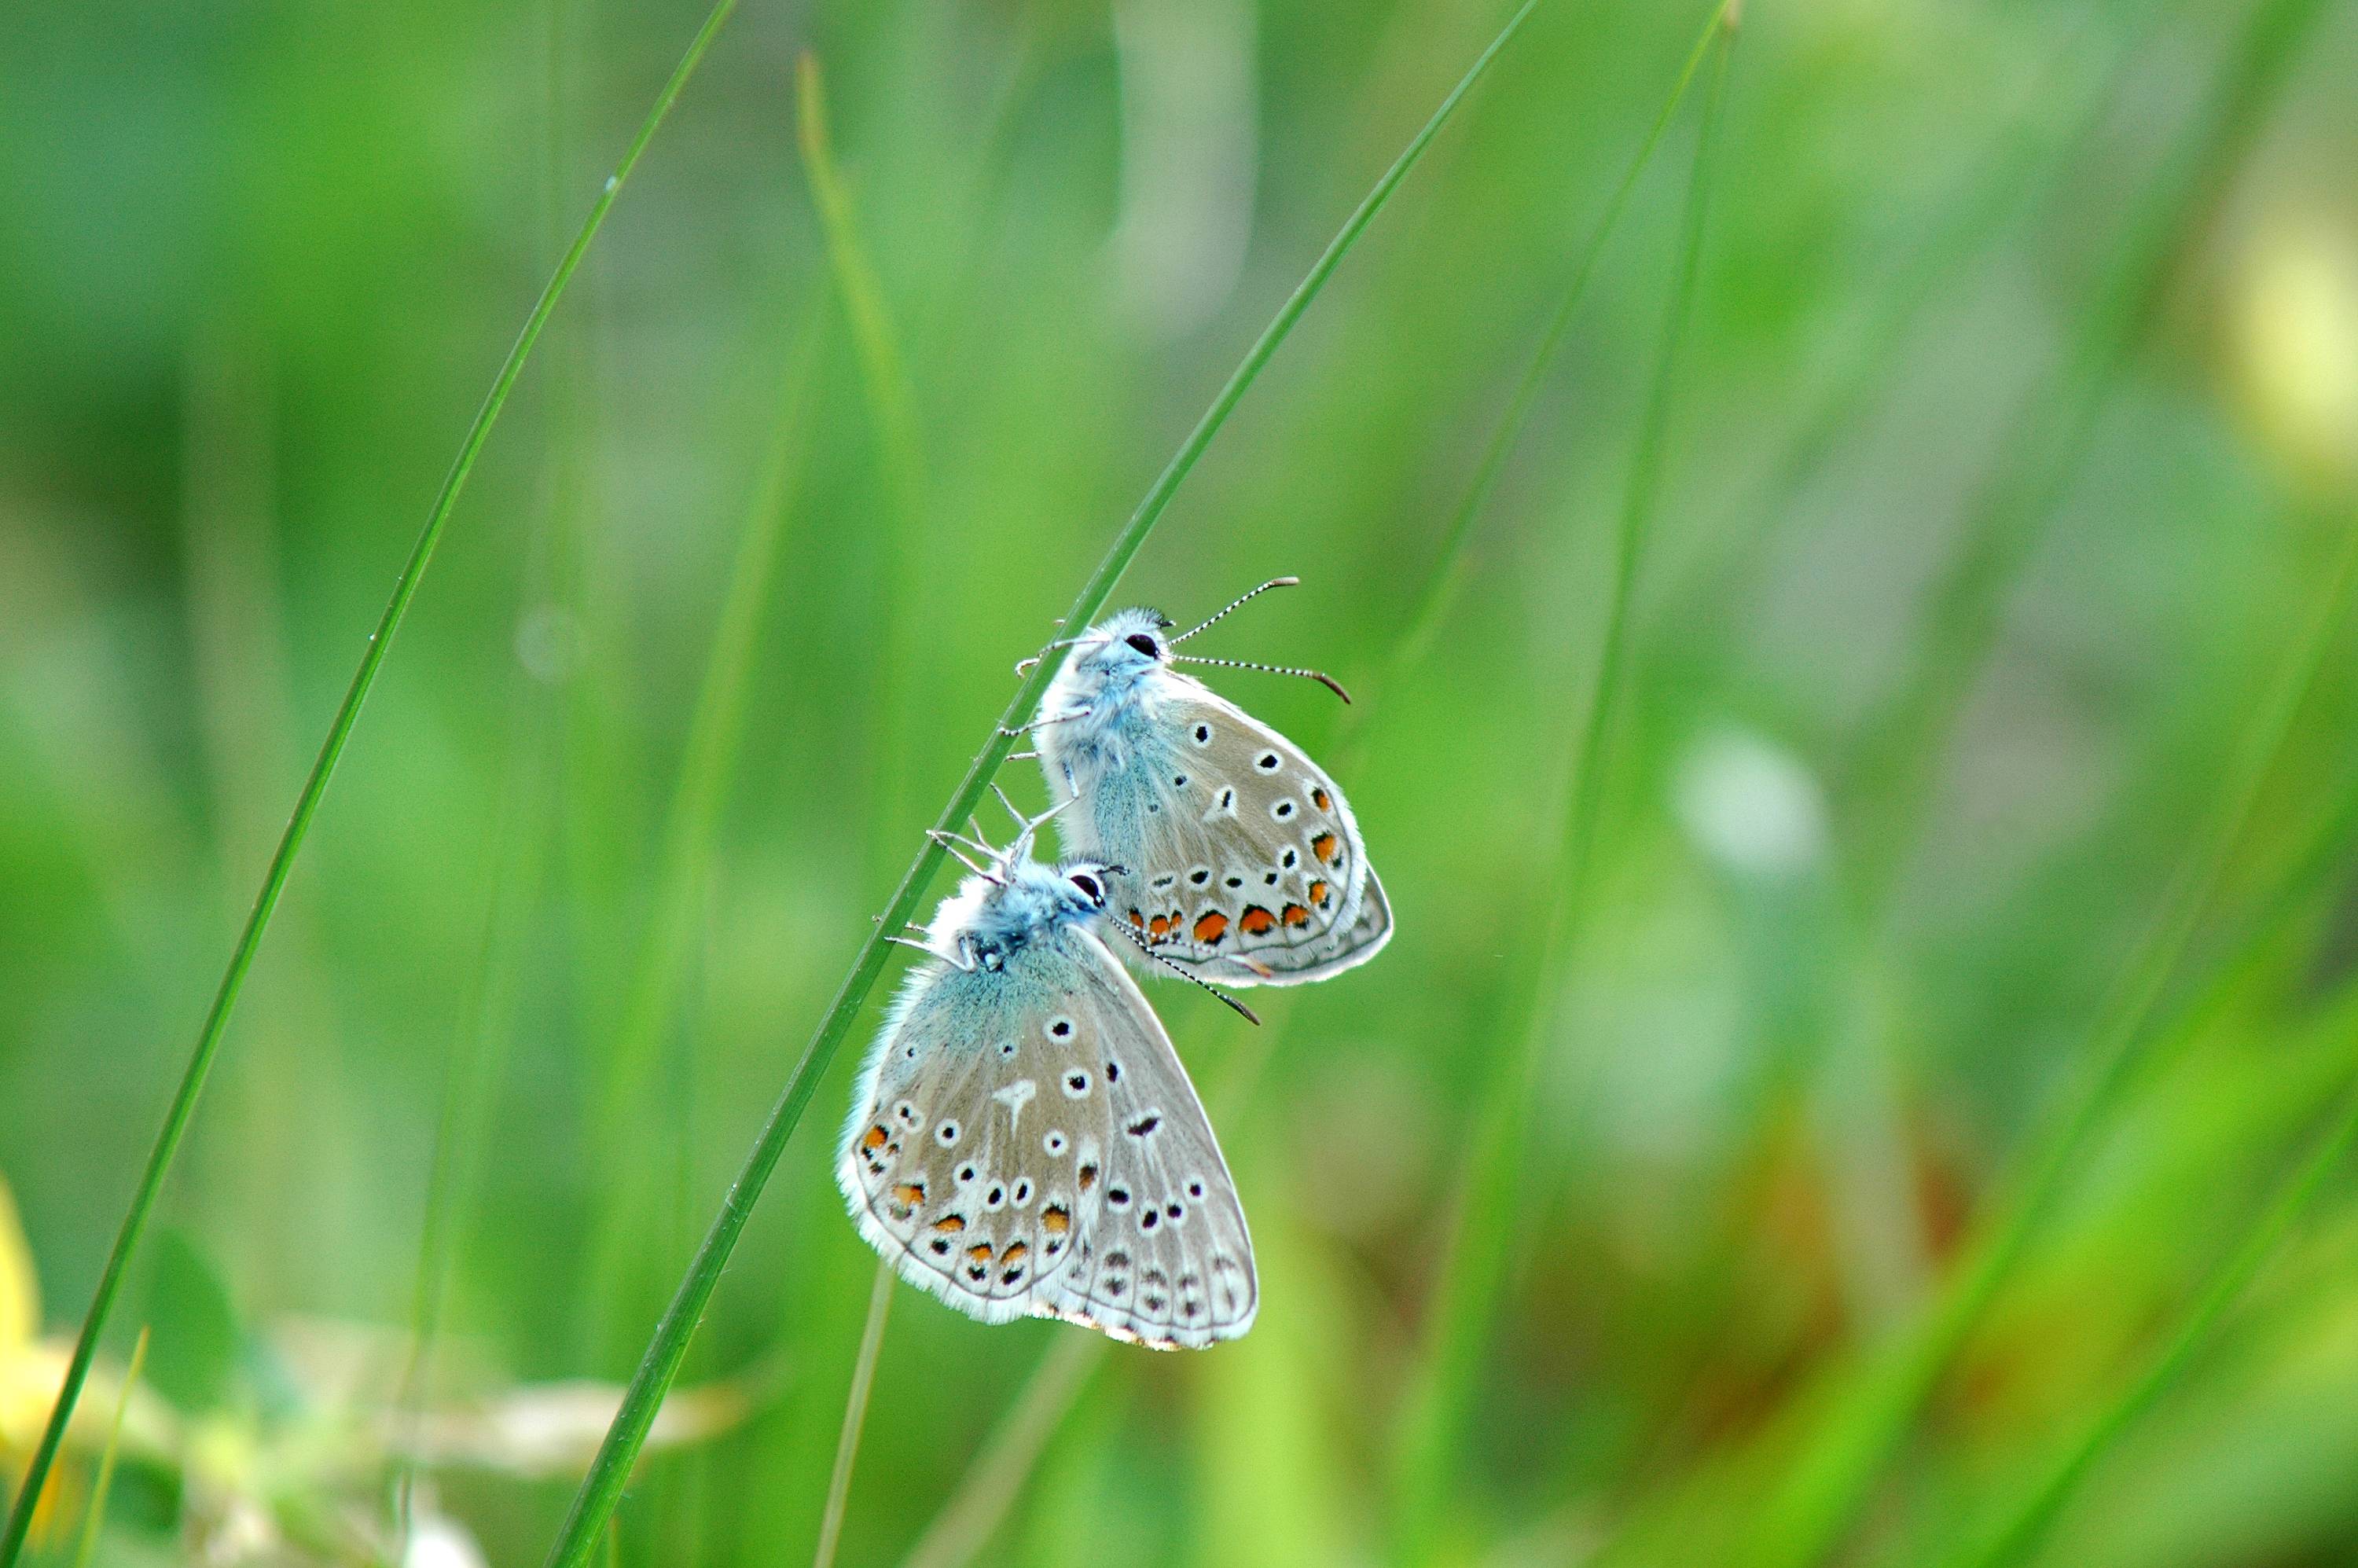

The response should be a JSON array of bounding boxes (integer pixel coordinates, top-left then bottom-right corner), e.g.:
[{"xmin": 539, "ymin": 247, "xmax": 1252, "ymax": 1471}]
[{"xmin": 1950, "ymin": 1009, "xmax": 2358, "ymax": 1568}]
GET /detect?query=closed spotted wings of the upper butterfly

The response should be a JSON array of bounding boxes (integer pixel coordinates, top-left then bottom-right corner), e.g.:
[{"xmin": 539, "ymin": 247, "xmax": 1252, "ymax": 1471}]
[{"xmin": 1061, "ymin": 672, "xmax": 1391, "ymax": 986}]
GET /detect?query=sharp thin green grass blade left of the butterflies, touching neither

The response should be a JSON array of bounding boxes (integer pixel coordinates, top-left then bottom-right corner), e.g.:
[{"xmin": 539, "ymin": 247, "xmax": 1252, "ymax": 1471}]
[{"xmin": 0, "ymin": 0, "xmax": 736, "ymax": 1568}]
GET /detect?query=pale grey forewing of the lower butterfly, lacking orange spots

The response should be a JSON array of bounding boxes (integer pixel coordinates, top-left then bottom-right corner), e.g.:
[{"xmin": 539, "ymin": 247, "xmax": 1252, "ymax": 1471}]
[{"xmin": 1040, "ymin": 936, "xmax": 1259, "ymax": 1349}]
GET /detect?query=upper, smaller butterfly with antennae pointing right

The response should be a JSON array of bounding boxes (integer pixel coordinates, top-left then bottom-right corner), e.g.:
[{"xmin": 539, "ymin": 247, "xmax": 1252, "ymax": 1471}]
[{"xmin": 1030, "ymin": 578, "xmax": 1391, "ymax": 986}]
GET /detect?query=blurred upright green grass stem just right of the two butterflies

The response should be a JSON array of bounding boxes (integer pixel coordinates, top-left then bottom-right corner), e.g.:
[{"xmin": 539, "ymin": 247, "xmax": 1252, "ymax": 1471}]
[{"xmin": 1394, "ymin": 12, "xmax": 1735, "ymax": 1563}]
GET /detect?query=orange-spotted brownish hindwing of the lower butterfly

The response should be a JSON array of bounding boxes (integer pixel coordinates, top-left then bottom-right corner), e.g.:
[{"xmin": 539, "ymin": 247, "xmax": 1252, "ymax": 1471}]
[{"xmin": 835, "ymin": 962, "xmax": 1118, "ymax": 1323}]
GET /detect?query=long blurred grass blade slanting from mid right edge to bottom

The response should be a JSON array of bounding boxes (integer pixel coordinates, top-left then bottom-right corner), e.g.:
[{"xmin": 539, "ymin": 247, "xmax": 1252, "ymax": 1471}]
[{"xmin": 1754, "ymin": 505, "xmax": 2358, "ymax": 1566}]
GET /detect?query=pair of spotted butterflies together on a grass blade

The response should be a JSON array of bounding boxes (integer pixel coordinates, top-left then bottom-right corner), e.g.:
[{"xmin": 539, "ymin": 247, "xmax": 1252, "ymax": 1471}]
[{"xmin": 835, "ymin": 578, "xmax": 1391, "ymax": 1349}]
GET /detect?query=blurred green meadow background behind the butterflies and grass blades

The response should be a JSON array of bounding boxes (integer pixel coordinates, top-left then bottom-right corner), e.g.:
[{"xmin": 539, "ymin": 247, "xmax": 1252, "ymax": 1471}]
[{"xmin": 0, "ymin": 0, "xmax": 2358, "ymax": 1568}]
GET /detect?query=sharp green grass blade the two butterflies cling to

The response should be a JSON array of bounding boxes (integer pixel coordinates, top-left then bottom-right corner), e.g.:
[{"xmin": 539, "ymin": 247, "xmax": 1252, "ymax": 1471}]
[{"xmin": 549, "ymin": 12, "xmax": 1540, "ymax": 1568}]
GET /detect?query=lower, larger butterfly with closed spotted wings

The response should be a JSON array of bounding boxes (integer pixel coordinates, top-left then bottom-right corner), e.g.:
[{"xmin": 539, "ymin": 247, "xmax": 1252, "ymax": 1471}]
[{"xmin": 835, "ymin": 797, "xmax": 1259, "ymax": 1349}]
